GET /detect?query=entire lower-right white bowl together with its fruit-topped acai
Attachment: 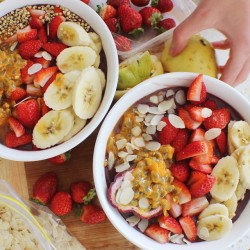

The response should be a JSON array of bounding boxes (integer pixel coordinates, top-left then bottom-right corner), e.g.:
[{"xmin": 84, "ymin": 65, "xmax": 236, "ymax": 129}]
[{"xmin": 93, "ymin": 72, "xmax": 250, "ymax": 250}]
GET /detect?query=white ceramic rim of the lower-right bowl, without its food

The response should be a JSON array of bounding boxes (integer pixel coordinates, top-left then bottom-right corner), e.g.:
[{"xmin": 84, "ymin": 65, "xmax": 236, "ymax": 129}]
[{"xmin": 93, "ymin": 73, "xmax": 250, "ymax": 250}]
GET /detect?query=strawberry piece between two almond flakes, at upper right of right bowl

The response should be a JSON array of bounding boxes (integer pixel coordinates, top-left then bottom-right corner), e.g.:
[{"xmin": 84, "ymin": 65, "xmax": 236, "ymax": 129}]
[{"xmin": 203, "ymin": 108, "xmax": 231, "ymax": 130}]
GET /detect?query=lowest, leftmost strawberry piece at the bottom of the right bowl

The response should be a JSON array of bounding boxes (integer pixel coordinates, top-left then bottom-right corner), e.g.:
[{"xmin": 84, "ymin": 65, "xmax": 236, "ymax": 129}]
[{"xmin": 145, "ymin": 223, "xmax": 169, "ymax": 244}]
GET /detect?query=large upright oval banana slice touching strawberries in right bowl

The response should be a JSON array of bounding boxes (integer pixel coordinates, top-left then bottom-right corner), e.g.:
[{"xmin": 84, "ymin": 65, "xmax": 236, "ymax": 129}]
[{"xmin": 210, "ymin": 156, "xmax": 239, "ymax": 202}]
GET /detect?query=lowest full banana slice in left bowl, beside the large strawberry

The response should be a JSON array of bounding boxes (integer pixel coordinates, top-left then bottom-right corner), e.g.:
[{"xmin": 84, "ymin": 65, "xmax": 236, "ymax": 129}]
[{"xmin": 33, "ymin": 110, "xmax": 74, "ymax": 148}]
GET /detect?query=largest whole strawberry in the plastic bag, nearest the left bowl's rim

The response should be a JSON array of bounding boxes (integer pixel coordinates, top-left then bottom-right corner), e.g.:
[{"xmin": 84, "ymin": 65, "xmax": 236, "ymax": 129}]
[{"xmin": 118, "ymin": 5, "xmax": 144, "ymax": 35}]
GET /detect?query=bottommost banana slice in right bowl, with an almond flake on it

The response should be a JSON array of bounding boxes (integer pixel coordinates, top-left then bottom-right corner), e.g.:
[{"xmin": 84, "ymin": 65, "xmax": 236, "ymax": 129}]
[{"xmin": 197, "ymin": 214, "xmax": 233, "ymax": 241}]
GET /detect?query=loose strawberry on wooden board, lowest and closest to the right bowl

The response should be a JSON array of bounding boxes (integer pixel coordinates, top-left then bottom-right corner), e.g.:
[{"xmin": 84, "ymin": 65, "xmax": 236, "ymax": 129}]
[{"xmin": 80, "ymin": 204, "xmax": 106, "ymax": 224}]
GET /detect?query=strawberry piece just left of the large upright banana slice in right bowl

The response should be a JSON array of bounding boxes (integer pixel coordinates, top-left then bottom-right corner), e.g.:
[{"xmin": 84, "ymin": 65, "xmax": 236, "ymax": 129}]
[{"xmin": 190, "ymin": 174, "xmax": 215, "ymax": 198}]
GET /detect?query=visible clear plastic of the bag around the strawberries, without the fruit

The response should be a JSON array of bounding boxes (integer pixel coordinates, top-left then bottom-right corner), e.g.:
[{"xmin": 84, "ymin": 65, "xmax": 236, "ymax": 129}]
[{"xmin": 90, "ymin": 0, "xmax": 196, "ymax": 58}]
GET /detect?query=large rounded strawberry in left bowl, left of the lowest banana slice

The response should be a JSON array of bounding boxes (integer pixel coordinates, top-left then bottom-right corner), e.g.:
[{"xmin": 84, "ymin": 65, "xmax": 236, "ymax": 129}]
[{"xmin": 14, "ymin": 99, "xmax": 41, "ymax": 128}]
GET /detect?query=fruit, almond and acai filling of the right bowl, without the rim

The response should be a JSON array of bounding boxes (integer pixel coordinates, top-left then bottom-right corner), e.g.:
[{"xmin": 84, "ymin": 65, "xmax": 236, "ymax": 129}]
[{"xmin": 105, "ymin": 74, "xmax": 250, "ymax": 244}]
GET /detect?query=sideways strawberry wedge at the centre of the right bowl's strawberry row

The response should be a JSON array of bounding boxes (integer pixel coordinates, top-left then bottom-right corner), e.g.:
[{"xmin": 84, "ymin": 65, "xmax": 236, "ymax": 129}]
[{"xmin": 176, "ymin": 141, "xmax": 208, "ymax": 161}]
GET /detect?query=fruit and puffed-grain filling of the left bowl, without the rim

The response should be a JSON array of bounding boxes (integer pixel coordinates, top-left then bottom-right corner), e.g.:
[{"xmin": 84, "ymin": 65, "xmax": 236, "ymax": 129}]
[{"xmin": 0, "ymin": 5, "xmax": 107, "ymax": 150}]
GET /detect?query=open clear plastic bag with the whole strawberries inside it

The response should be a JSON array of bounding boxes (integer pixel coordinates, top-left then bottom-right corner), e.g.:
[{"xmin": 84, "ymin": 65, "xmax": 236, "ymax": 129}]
[{"xmin": 91, "ymin": 0, "xmax": 195, "ymax": 58}]
